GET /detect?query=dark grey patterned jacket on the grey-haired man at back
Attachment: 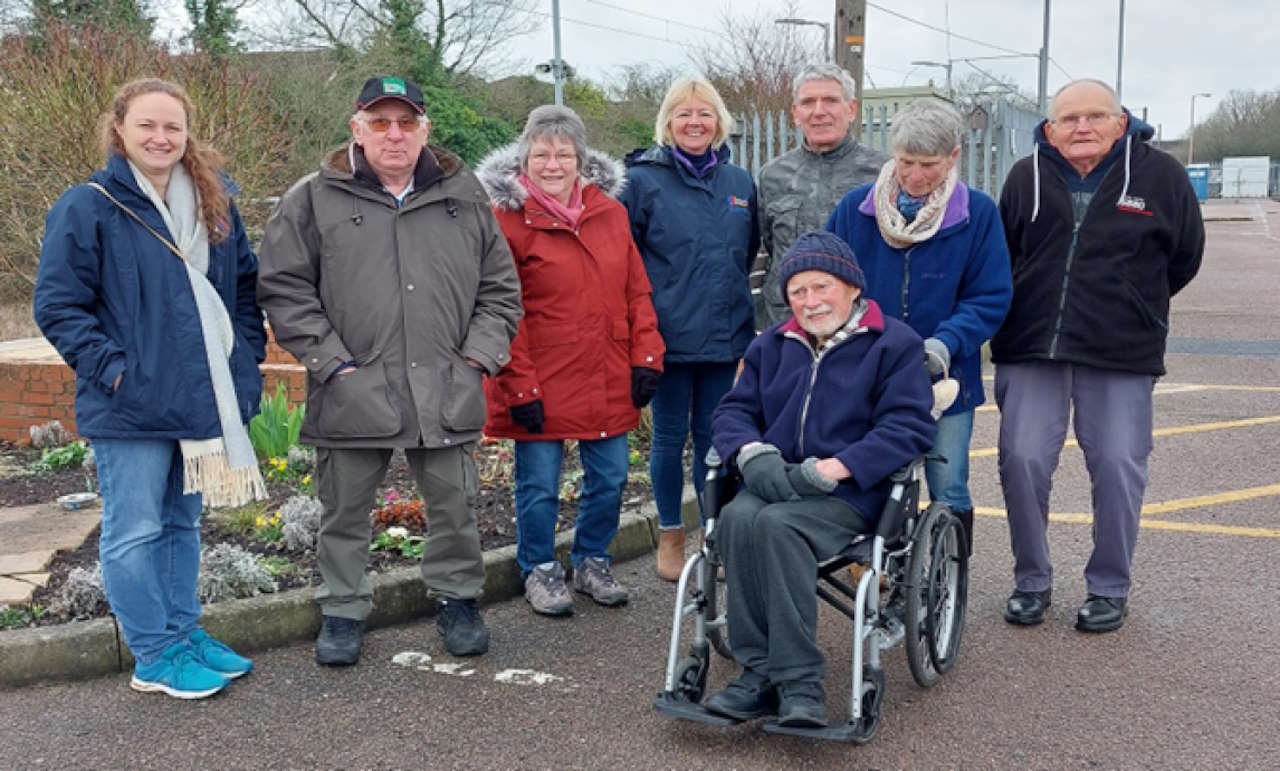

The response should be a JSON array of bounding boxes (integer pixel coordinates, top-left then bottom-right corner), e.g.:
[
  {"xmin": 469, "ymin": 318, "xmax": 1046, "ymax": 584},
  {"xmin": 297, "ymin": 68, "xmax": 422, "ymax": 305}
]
[{"xmin": 755, "ymin": 137, "xmax": 888, "ymax": 325}]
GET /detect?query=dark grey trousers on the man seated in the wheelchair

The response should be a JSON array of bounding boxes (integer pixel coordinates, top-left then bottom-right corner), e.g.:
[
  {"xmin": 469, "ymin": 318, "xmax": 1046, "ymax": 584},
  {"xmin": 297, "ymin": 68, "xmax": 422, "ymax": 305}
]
[{"xmin": 717, "ymin": 489, "xmax": 869, "ymax": 685}]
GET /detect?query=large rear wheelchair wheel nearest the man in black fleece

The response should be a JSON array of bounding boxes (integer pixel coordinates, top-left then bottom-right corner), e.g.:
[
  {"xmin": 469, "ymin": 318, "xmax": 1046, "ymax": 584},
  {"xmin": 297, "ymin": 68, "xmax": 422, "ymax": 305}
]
[{"xmin": 904, "ymin": 505, "xmax": 969, "ymax": 688}]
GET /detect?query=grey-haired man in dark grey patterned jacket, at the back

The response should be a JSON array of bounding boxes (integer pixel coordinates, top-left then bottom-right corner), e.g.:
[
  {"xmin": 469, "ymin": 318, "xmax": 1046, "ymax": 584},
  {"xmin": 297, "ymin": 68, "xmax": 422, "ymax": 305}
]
[{"xmin": 755, "ymin": 64, "xmax": 888, "ymax": 330}]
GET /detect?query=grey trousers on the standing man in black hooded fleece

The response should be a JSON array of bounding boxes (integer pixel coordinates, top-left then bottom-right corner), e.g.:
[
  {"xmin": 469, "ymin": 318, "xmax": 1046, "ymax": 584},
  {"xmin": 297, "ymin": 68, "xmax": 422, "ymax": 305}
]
[{"xmin": 996, "ymin": 361, "xmax": 1156, "ymax": 597}]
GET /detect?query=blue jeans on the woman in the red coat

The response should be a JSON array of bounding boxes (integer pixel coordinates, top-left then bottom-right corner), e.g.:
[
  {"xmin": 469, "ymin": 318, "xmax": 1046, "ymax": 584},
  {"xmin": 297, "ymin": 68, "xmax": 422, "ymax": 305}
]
[{"xmin": 516, "ymin": 434, "xmax": 628, "ymax": 578}]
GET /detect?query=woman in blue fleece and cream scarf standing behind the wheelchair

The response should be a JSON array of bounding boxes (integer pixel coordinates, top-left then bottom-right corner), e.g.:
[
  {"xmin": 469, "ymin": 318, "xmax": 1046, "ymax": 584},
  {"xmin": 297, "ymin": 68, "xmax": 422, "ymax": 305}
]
[{"xmin": 827, "ymin": 101, "xmax": 1014, "ymax": 551}]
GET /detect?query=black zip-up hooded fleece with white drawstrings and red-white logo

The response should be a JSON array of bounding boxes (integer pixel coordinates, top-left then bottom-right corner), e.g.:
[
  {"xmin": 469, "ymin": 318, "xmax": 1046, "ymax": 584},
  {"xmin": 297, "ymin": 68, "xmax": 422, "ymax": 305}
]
[{"xmin": 991, "ymin": 115, "xmax": 1204, "ymax": 375}]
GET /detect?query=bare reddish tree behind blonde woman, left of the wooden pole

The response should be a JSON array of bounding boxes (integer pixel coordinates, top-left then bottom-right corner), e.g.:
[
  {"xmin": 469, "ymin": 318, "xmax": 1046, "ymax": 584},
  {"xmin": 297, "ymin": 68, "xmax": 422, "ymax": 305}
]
[{"xmin": 692, "ymin": 0, "xmax": 826, "ymax": 111}]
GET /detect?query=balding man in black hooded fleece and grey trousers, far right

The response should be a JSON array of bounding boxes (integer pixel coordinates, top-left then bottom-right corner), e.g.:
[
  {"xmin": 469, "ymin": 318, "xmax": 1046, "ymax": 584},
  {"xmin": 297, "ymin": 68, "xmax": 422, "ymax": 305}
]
[{"xmin": 991, "ymin": 79, "xmax": 1204, "ymax": 631}]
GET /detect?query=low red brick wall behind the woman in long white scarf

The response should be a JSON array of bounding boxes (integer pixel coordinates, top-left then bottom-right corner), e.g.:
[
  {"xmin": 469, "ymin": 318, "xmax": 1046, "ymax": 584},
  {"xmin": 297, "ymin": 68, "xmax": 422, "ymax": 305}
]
[{"xmin": 0, "ymin": 332, "xmax": 307, "ymax": 444}]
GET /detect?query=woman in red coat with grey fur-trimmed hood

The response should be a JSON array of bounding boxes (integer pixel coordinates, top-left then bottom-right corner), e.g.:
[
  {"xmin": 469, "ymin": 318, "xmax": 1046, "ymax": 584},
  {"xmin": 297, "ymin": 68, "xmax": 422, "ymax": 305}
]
[{"xmin": 479, "ymin": 105, "xmax": 663, "ymax": 616}]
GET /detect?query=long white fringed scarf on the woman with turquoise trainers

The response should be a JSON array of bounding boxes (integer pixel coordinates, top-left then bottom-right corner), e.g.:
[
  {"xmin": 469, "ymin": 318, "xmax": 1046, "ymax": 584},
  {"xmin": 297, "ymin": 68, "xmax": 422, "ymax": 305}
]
[{"xmin": 129, "ymin": 161, "xmax": 266, "ymax": 506}]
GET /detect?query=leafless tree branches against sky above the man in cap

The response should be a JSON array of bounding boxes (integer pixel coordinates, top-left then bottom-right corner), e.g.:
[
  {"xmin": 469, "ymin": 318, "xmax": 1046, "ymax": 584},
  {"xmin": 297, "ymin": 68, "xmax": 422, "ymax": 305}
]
[{"xmin": 255, "ymin": 0, "xmax": 539, "ymax": 76}]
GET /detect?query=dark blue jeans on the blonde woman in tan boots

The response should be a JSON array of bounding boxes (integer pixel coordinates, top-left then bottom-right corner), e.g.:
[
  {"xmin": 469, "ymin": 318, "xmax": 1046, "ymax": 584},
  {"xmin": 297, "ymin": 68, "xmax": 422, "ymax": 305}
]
[{"xmin": 649, "ymin": 362, "xmax": 737, "ymax": 528}]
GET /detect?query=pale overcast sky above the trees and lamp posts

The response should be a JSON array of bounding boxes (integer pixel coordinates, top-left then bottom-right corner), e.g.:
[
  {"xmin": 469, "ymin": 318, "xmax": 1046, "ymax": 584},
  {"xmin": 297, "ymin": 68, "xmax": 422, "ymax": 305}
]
[{"xmin": 155, "ymin": 0, "xmax": 1280, "ymax": 140}]
